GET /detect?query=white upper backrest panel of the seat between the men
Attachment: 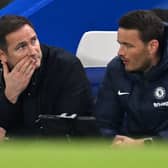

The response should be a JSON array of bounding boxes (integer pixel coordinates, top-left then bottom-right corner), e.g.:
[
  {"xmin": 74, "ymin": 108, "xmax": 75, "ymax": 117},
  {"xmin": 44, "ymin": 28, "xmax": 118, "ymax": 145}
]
[{"xmin": 76, "ymin": 31, "xmax": 119, "ymax": 68}]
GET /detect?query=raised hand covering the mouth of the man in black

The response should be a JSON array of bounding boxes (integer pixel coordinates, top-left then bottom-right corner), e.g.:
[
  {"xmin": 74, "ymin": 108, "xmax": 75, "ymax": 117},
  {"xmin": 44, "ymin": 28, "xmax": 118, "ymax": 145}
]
[{"xmin": 2, "ymin": 57, "xmax": 36, "ymax": 104}]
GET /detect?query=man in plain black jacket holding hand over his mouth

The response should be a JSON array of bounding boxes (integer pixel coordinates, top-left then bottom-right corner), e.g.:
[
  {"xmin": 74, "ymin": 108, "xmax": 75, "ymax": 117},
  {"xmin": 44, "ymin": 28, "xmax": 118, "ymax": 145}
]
[{"xmin": 0, "ymin": 15, "xmax": 92, "ymax": 139}]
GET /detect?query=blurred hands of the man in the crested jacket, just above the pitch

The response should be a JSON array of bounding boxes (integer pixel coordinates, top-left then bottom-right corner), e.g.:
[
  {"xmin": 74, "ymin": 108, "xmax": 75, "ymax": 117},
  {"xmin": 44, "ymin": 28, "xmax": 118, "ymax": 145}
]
[{"xmin": 112, "ymin": 135, "xmax": 144, "ymax": 147}]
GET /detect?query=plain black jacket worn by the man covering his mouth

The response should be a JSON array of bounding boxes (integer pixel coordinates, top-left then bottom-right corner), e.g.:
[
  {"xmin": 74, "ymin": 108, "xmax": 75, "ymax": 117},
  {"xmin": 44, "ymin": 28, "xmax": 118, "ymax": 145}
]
[{"xmin": 0, "ymin": 45, "xmax": 92, "ymax": 134}]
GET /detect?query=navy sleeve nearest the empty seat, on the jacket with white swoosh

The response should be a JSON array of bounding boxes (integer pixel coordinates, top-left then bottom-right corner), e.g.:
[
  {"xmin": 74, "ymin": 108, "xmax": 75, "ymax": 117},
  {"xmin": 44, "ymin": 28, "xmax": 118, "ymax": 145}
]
[{"xmin": 96, "ymin": 66, "xmax": 124, "ymax": 137}]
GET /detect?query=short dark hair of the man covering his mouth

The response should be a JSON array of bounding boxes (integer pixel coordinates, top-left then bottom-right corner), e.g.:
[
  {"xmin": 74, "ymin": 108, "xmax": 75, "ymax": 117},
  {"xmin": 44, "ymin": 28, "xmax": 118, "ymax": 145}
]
[{"xmin": 0, "ymin": 15, "xmax": 34, "ymax": 52}]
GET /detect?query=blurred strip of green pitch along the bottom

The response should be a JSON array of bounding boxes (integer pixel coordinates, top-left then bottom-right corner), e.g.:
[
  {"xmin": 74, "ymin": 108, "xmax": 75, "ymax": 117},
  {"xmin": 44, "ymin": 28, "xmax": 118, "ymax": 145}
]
[{"xmin": 0, "ymin": 139, "xmax": 168, "ymax": 168}]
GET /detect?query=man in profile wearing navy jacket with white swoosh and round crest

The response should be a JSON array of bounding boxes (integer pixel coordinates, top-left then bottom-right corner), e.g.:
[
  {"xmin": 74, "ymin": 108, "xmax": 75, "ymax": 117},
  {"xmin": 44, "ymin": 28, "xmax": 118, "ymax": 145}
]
[{"xmin": 96, "ymin": 10, "xmax": 168, "ymax": 146}]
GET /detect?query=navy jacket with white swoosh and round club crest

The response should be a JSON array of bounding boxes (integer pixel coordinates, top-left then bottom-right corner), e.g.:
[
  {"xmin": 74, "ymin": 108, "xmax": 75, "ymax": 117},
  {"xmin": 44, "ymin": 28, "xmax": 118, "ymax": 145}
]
[{"xmin": 96, "ymin": 27, "xmax": 168, "ymax": 138}]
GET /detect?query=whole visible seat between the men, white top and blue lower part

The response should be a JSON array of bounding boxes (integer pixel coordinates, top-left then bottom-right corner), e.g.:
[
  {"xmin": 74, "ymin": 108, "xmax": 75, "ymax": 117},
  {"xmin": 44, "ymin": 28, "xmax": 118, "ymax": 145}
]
[{"xmin": 76, "ymin": 31, "xmax": 119, "ymax": 97}]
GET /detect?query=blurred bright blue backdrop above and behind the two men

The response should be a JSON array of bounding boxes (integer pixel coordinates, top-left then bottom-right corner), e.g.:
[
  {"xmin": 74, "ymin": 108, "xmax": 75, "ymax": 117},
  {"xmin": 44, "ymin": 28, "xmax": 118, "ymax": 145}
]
[{"xmin": 0, "ymin": 0, "xmax": 168, "ymax": 54}]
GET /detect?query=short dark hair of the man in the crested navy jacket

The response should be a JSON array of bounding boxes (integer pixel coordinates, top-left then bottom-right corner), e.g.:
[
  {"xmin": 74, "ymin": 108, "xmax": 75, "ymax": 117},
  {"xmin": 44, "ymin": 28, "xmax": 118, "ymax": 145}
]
[{"xmin": 119, "ymin": 10, "xmax": 164, "ymax": 54}]
